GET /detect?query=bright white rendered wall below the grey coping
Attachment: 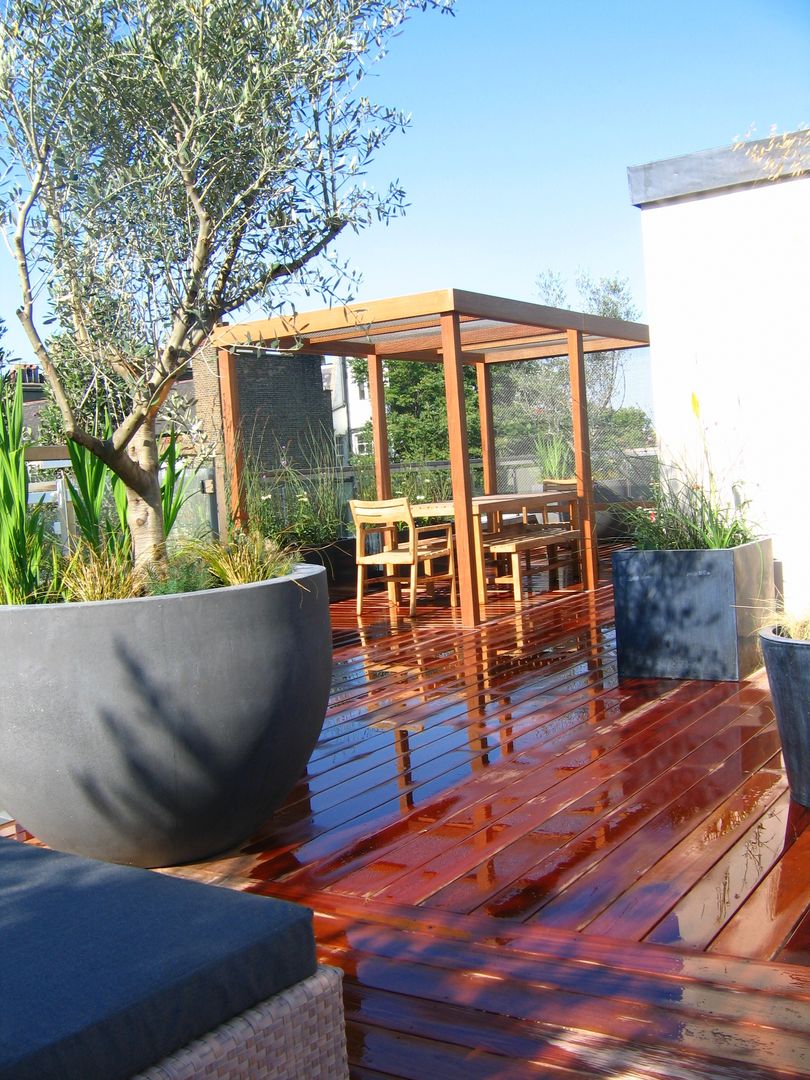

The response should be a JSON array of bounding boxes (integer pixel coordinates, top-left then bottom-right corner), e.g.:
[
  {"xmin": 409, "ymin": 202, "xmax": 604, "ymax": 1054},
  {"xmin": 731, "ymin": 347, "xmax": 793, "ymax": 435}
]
[{"xmin": 642, "ymin": 177, "xmax": 810, "ymax": 608}]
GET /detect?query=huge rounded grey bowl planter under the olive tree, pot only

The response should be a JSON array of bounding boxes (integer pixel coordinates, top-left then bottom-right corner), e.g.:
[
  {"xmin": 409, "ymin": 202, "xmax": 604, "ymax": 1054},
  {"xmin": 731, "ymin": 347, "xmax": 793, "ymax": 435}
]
[{"xmin": 0, "ymin": 566, "xmax": 332, "ymax": 866}]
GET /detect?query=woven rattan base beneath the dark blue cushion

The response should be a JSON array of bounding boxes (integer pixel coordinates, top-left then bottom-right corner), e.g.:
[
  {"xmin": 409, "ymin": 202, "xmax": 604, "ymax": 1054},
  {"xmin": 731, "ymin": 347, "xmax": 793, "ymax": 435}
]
[{"xmin": 135, "ymin": 967, "xmax": 349, "ymax": 1080}]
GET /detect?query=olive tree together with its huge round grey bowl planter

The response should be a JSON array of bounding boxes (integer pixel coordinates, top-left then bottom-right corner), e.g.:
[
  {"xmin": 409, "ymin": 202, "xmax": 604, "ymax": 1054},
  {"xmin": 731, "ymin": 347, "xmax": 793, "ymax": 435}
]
[{"xmin": 0, "ymin": 0, "xmax": 450, "ymax": 865}]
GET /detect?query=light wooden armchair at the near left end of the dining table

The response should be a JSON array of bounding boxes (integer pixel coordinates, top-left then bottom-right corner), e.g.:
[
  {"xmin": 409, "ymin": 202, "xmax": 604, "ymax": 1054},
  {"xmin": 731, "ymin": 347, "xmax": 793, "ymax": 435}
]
[{"xmin": 349, "ymin": 499, "xmax": 456, "ymax": 617}]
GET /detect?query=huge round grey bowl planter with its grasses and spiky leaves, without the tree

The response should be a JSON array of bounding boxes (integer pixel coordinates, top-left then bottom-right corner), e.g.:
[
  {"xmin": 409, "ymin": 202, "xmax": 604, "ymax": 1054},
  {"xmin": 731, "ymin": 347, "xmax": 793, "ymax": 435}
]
[{"xmin": 0, "ymin": 379, "xmax": 332, "ymax": 865}]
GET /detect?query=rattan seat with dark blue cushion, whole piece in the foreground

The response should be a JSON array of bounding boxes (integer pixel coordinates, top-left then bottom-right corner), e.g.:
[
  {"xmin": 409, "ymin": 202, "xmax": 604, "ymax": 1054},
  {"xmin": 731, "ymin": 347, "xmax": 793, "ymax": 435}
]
[{"xmin": 0, "ymin": 839, "xmax": 348, "ymax": 1080}]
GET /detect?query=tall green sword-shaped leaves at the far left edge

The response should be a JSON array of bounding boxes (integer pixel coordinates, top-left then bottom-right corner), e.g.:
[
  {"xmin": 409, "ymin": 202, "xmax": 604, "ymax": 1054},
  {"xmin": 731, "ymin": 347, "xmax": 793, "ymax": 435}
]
[{"xmin": 0, "ymin": 377, "xmax": 46, "ymax": 604}]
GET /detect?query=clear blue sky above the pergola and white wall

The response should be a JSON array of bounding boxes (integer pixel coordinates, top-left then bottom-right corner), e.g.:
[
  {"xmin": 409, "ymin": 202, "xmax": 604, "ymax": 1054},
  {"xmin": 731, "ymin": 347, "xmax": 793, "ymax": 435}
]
[{"xmin": 0, "ymin": 0, "xmax": 810, "ymax": 367}]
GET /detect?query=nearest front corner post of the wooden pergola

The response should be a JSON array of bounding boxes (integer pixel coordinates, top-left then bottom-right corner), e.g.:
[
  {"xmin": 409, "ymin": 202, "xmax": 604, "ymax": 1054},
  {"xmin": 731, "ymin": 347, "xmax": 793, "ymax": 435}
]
[{"xmin": 440, "ymin": 311, "xmax": 481, "ymax": 626}]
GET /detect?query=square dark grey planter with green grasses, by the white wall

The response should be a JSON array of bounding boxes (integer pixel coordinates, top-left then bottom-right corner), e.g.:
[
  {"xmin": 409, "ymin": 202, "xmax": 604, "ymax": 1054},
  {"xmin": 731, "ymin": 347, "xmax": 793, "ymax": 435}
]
[{"xmin": 612, "ymin": 478, "xmax": 773, "ymax": 680}]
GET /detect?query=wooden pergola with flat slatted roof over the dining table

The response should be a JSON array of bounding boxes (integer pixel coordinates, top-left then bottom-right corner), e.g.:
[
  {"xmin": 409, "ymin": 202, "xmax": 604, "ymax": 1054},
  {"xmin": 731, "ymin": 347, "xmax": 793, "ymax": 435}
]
[{"xmin": 213, "ymin": 288, "xmax": 649, "ymax": 626}]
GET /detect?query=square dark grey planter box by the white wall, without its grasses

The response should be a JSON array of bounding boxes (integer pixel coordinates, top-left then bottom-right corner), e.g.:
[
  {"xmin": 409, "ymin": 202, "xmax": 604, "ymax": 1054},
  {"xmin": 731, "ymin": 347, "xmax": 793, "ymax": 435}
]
[{"xmin": 613, "ymin": 540, "xmax": 773, "ymax": 681}]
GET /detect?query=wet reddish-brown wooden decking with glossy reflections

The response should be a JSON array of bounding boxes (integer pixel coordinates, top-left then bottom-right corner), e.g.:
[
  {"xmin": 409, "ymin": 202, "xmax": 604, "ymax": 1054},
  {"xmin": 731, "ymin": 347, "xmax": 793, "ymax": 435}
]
[{"xmin": 6, "ymin": 585, "xmax": 810, "ymax": 1080}]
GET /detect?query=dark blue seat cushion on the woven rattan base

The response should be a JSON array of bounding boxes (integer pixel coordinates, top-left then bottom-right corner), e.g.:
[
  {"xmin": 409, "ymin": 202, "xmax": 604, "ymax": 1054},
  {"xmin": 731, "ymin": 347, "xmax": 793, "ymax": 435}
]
[{"xmin": 0, "ymin": 839, "xmax": 315, "ymax": 1080}]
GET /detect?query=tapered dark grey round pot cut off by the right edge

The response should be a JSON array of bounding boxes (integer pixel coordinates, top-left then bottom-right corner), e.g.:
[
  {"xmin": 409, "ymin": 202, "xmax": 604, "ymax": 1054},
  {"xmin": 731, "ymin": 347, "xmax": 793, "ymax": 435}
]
[{"xmin": 759, "ymin": 626, "xmax": 810, "ymax": 807}]
